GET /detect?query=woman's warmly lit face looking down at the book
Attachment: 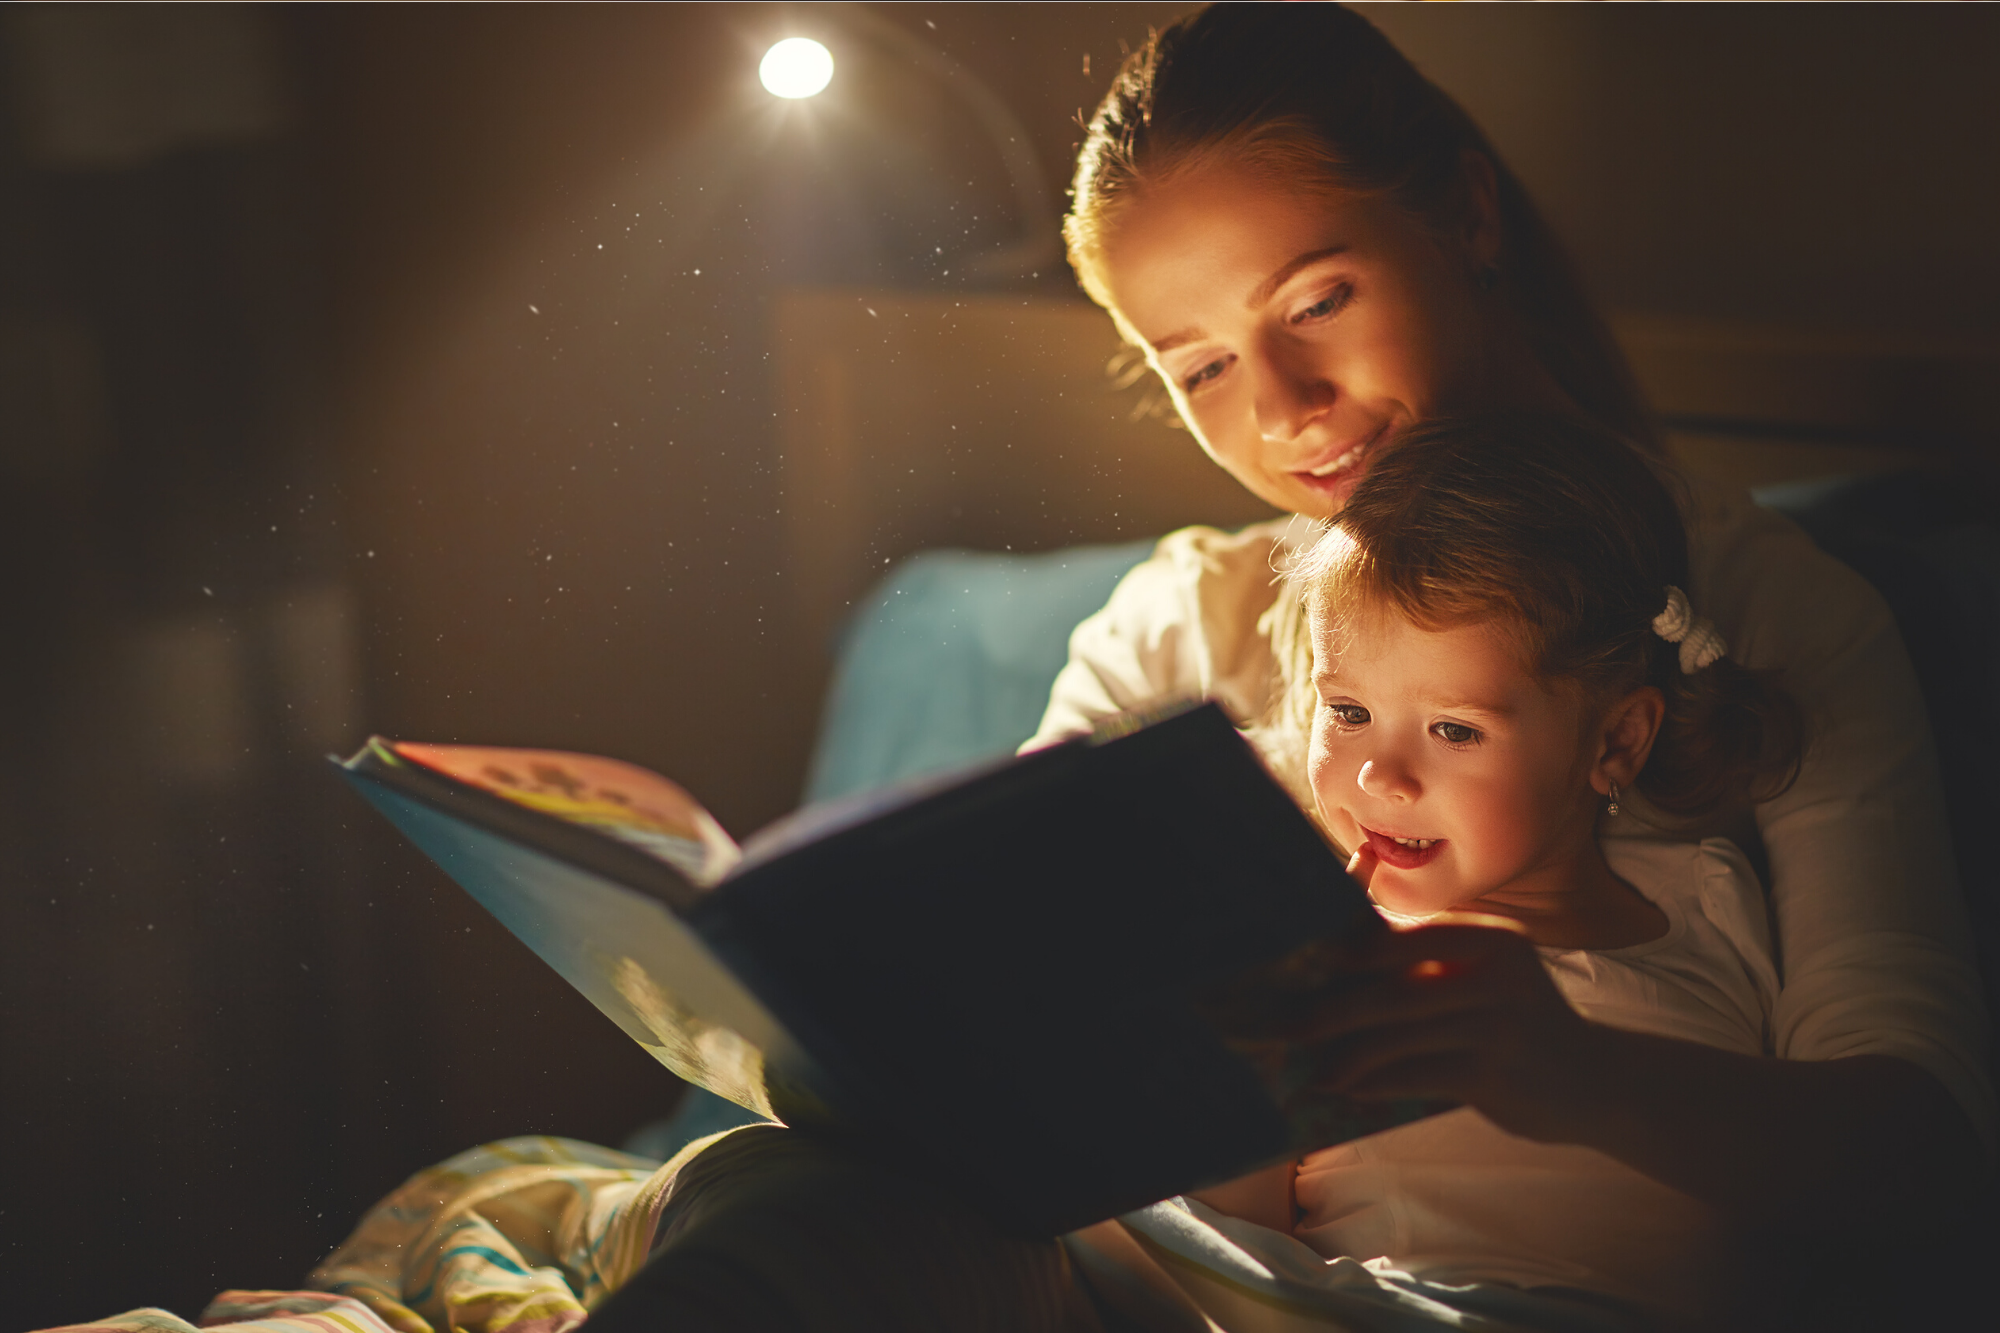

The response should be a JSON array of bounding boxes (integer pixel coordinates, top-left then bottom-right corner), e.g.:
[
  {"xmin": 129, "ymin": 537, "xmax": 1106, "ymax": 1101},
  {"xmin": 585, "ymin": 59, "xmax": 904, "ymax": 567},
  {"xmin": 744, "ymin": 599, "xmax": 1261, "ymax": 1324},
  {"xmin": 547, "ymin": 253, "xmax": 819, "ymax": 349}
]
[{"xmin": 1098, "ymin": 166, "xmax": 1490, "ymax": 518}]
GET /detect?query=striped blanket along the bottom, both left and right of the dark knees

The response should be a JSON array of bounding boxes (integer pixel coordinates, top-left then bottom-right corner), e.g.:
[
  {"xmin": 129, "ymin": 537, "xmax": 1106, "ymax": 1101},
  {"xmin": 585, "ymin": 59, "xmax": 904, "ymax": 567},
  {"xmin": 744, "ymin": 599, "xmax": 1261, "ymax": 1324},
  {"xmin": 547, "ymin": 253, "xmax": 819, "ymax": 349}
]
[{"xmin": 44, "ymin": 1131, "xmax": 1644, "ymax": 1333}]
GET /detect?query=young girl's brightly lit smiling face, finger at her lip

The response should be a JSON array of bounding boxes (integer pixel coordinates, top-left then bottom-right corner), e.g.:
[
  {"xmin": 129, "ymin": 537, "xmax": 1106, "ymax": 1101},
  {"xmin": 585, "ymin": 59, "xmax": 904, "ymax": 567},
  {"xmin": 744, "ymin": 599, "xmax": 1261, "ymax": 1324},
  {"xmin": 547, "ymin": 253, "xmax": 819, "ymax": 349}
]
[{"xmin": 1308, "ymin": 612, "xmax": 1598, "ymax": 917}]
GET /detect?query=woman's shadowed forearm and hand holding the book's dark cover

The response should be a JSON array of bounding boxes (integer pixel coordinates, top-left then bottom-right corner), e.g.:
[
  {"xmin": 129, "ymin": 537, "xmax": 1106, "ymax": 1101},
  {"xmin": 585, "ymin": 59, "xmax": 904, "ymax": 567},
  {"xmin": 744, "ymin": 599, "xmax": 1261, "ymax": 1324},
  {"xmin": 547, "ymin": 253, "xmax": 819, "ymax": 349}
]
[{"xmin": 1310, "ymin": 925, "xmax": 1984, "ymax": 1229}]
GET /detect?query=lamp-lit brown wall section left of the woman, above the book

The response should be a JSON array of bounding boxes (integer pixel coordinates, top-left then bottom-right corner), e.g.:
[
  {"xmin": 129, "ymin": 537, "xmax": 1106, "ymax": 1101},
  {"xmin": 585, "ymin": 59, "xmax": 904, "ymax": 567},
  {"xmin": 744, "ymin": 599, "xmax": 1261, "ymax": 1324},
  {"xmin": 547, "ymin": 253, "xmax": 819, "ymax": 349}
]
[{"xmin": 304, "ymin": 6, "xmax": 1170, "ymax": 833}]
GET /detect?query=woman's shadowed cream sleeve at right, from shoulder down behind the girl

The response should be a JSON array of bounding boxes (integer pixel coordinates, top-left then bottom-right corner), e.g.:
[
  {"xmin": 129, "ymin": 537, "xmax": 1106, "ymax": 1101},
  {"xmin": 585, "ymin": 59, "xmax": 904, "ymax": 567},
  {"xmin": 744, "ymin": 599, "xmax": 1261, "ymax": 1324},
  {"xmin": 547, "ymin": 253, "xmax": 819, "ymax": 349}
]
[{"xmin": 1690, "ymin": 478, "xmax": 1996, "ymax": 1155}]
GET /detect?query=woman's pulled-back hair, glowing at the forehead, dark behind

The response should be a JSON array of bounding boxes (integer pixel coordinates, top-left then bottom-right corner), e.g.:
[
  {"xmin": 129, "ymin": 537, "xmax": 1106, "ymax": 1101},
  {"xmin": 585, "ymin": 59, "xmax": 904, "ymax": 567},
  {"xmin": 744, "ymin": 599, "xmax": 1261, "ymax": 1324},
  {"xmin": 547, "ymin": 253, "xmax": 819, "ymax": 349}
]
[{"xmin": 1062, "ymin": 4, "xmax": 1658, "ymax": 450}]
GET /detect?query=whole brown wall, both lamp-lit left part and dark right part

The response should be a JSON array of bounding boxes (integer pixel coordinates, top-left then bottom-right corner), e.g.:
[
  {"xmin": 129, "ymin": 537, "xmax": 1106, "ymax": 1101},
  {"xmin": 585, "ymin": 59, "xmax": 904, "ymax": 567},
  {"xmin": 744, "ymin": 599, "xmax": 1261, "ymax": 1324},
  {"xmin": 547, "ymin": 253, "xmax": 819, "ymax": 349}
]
[{"xmin": 320, "ymin": 6, "xmax": 2000, "ymax": 829}]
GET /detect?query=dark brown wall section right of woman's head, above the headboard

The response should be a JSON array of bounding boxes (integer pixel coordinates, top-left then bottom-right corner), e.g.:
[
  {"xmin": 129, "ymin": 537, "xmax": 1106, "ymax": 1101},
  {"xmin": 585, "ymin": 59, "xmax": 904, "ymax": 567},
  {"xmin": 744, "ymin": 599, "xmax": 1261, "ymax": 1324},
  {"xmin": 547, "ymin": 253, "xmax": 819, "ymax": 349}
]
[{"xmin": 1360, "ymin": 4, "xmax": 2000, "ymax": 342}]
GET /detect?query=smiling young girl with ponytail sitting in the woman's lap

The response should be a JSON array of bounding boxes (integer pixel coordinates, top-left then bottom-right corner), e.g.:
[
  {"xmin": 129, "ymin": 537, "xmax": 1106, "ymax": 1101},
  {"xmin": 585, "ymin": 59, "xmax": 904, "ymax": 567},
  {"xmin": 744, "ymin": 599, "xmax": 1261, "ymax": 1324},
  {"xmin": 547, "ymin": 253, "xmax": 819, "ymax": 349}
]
[{"xmin": 1176, "ymin": 414, "xmax": 1802, "ymax": 1315}]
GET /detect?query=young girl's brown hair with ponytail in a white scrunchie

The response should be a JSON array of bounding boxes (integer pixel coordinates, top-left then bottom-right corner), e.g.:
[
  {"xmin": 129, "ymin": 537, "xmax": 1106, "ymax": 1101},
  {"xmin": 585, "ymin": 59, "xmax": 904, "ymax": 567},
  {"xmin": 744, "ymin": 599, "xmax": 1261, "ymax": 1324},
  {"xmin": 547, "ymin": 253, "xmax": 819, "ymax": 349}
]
[{"xmin": 1290, "ymin": 412, "xmax": 1804, "ymax": 815}]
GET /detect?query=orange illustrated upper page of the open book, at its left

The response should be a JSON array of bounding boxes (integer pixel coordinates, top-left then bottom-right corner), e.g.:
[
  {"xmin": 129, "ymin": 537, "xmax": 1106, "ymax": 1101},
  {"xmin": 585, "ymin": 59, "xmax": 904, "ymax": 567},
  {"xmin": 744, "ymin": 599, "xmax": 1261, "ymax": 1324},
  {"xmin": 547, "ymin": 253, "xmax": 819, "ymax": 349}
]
[{"xmin": 390, "ymin": 741, "xmax": 742, "ymax": 889}]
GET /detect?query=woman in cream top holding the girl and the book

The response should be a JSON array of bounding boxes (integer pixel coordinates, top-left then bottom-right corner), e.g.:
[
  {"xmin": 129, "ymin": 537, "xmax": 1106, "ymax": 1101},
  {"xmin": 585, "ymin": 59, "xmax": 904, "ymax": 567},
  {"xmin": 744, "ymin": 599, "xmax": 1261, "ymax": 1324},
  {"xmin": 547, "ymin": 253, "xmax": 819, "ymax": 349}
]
[{"xmin": 1036, "ymin": 6, "xmax": 1992, "ymax": 1320}]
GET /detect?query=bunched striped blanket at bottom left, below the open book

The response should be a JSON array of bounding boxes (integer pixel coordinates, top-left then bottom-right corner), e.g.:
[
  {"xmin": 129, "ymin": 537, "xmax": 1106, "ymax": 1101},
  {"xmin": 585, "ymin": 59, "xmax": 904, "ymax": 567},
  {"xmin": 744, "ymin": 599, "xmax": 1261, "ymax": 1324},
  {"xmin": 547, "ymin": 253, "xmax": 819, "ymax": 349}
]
[{"xmin": 50, "ymin": 1137, "xmax": 712, "ymax": 1333}]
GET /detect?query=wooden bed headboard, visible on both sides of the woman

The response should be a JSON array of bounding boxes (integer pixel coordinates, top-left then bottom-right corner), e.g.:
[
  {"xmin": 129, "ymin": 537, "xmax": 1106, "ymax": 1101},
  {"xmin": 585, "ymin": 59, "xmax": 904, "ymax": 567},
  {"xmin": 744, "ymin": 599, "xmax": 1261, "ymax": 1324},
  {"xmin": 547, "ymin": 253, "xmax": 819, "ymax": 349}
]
[{"xmin": 772, "ymin": 290, "xmax": 2000, "ymax": 642}]
